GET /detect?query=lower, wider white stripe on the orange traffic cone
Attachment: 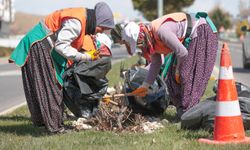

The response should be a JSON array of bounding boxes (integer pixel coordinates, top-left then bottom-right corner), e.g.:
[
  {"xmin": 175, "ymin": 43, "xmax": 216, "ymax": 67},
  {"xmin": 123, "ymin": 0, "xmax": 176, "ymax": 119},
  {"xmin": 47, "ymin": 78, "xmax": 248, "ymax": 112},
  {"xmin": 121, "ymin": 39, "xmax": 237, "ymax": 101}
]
[{"xmin": 215, "ymin": 100, "xmax": 241, "ymax": 117}]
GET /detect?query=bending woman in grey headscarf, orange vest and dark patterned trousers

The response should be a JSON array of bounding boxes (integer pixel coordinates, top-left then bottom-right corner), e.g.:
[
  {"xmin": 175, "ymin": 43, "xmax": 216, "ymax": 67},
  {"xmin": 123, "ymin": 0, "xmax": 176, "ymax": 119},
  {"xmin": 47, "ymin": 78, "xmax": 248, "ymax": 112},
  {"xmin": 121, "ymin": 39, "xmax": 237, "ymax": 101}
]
[{"xmin": 10, "ymin": 2, "xmax": 114, "ymax": 133}]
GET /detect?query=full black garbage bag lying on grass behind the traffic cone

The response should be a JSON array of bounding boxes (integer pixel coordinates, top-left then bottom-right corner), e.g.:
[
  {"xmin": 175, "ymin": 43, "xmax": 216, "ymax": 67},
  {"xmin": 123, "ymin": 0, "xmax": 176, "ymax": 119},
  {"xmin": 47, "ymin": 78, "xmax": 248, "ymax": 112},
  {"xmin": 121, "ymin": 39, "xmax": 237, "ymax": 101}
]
[{"xmin": 181, "ymin": 82, "xmax": 250, "ymax": 131}]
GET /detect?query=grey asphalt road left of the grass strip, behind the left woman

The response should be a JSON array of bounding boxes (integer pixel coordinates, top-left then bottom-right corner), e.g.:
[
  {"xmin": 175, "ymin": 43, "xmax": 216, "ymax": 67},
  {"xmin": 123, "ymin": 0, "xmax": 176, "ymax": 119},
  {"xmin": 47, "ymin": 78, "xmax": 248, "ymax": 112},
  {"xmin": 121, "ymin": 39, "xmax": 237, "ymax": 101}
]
[{"xmin": 0, "ymin": 45, "xmax": 129, "ymax": 114}]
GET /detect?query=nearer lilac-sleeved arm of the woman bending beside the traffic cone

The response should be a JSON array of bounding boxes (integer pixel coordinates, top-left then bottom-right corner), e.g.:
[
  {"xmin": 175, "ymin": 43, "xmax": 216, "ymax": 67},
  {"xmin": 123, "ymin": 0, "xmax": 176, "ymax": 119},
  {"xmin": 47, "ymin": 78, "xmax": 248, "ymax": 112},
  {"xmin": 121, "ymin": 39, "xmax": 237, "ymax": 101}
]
[{"xmin": 157, "ymin": 21, "xmax": 188, "ymax": 68}]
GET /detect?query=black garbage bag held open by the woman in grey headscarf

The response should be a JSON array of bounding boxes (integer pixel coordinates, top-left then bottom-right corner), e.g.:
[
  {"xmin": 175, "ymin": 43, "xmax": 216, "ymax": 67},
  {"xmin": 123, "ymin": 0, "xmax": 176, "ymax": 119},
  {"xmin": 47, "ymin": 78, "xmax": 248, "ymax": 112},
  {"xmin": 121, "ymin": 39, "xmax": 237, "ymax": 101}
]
[{"xmin": 63, "ymin": 57, "xmax": 111, "ymax": 118}]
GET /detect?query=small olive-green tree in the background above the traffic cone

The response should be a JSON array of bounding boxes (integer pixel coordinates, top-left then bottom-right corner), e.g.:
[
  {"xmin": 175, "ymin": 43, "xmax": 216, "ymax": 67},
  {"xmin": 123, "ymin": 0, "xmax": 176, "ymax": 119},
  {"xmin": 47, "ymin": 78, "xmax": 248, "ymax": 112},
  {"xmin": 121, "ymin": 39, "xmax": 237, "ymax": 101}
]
[{"xmin": 209, "ymin": 6, "xmax": 232, "ymax": 29}]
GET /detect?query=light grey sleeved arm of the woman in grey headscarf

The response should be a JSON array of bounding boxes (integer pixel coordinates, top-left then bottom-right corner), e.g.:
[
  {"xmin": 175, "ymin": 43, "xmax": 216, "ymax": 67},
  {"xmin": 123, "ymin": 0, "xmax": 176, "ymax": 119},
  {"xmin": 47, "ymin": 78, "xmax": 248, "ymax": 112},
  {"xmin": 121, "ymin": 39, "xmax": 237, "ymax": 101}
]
[{"xmin": 55, "ymin": 19, "xmax": 88, "ymax": 61}]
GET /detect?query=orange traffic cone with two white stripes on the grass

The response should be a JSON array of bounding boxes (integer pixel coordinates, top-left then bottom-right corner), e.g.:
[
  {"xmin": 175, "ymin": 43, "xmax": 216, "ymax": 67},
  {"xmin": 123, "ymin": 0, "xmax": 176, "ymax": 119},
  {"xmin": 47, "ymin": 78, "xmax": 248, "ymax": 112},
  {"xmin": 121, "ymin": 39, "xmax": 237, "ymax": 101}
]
[{"xmin": 199, "ymin": 43, "xmax": 250, "ymax": 144}]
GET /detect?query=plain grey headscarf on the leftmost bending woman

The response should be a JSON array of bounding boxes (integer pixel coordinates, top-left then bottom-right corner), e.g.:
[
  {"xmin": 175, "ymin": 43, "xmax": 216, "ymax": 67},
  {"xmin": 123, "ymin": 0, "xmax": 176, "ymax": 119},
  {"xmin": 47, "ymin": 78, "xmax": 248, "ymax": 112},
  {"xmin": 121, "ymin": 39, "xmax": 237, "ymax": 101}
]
[{"xmin": 95, "ymin": 2, "xmax": 115, "ymax": 29}]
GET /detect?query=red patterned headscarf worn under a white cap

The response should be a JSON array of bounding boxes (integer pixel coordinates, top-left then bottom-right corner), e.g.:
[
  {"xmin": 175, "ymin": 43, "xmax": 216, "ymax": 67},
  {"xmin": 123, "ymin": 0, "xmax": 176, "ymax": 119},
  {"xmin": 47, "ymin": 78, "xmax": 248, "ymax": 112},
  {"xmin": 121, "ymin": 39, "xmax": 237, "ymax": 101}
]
[{"xmin": 137, "ymin": 23, "xmax": 154, "ymax": 61}]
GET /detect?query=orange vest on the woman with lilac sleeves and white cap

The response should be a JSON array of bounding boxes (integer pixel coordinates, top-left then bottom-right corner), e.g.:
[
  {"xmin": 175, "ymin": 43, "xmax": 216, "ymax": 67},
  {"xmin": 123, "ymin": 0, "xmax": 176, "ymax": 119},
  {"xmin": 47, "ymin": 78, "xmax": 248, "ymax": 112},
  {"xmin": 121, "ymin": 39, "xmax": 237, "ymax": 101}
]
[{"xmin": 151, "ymin": 12, "xmax": 187, "ymax": 55}]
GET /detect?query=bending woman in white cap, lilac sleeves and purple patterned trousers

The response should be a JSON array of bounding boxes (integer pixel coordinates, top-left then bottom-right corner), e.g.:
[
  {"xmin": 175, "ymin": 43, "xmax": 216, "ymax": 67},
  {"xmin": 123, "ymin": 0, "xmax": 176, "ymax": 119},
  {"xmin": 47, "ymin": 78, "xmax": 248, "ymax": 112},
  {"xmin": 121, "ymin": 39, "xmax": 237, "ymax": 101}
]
[{"xmin": 111, "ymin": 12, "xmax": 218, "ymax": 118}]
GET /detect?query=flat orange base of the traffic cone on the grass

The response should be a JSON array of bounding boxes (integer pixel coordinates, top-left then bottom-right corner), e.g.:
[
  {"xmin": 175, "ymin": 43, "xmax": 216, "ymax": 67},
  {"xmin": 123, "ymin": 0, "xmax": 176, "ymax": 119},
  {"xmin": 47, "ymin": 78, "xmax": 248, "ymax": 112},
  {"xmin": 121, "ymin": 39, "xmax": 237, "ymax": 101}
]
[{"xmin": 198, "ymin": 137, "xmax": 250, "ymax": 144}]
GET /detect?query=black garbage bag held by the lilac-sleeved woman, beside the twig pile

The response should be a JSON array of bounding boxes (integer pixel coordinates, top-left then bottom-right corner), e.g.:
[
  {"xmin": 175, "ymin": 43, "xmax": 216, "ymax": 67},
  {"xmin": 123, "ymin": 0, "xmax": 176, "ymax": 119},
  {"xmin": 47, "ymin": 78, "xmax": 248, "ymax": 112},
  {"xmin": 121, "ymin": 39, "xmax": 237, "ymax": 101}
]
[{"xmin": 124, "ymin": 67, "xmax": 170, "ymax": 116}]
